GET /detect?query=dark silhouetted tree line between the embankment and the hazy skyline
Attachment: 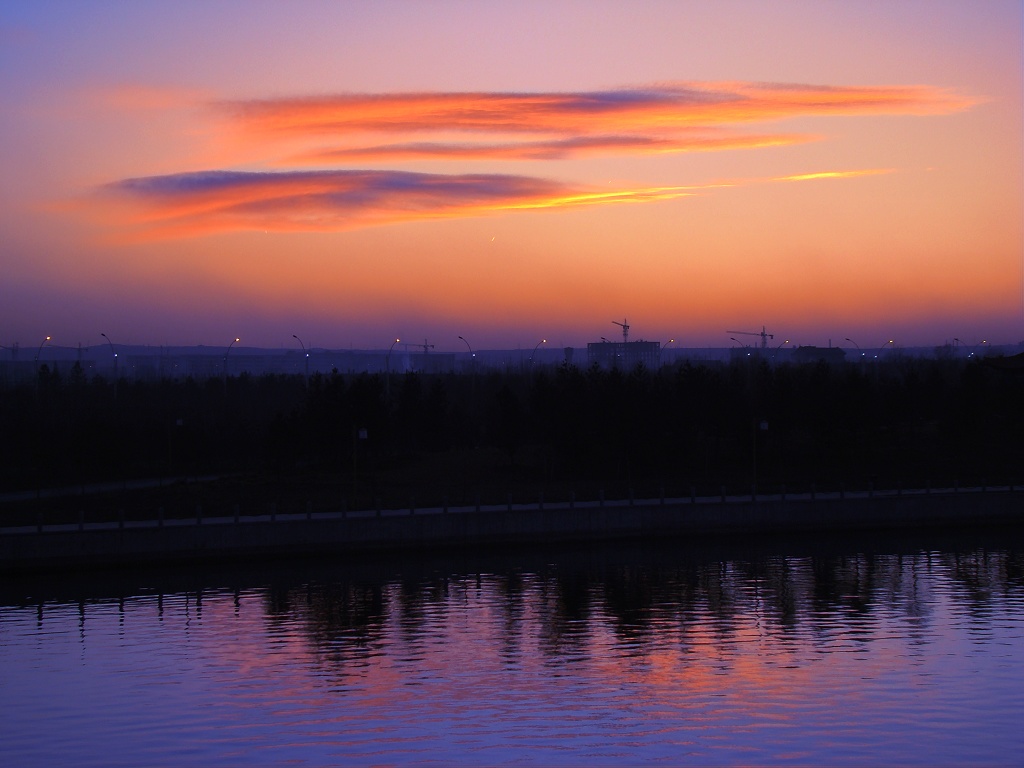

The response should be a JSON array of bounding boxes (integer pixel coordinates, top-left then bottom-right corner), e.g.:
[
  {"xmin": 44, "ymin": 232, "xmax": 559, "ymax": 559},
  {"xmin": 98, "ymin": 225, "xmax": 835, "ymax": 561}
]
[{"xmin": 0, "ymin": 357, "xmax": 1024, "ymax": 514}]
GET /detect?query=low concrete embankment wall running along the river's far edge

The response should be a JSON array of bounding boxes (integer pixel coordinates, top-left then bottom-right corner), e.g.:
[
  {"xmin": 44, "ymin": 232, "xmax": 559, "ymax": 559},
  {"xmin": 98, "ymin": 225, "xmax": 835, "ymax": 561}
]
[{"xmin": 0, "ymin": 488, "xmax": 1024, "ymax": 570}]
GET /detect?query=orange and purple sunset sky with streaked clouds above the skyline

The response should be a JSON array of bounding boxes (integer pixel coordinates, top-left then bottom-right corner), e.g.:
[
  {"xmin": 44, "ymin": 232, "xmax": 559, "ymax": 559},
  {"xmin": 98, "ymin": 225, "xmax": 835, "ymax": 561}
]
[{"xmin": 0, "ymin": 0, "xmax": 1024, "ymax": 351}]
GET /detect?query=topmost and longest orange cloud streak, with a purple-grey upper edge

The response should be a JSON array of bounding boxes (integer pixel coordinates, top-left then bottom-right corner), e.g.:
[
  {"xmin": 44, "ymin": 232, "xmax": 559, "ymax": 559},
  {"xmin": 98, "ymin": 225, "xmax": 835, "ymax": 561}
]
[{"xmin": 219, "ymin": 83, "xmax": 973, "ymax": 148}]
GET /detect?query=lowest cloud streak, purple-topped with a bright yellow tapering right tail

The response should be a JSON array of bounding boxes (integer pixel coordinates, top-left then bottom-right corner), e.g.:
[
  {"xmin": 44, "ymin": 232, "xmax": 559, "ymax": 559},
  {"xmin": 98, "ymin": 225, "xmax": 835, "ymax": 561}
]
[{"xmin": 92, "ymin": 171, "xmax": 691, "ymax": 240}]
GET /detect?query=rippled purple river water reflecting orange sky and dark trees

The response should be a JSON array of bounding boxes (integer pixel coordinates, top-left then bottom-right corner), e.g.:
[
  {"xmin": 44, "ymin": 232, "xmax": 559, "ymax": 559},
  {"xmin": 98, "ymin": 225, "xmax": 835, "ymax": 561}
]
[{"xmin": 0, "ymin": 534, "xmax": 1024, "ymax": 766}]
